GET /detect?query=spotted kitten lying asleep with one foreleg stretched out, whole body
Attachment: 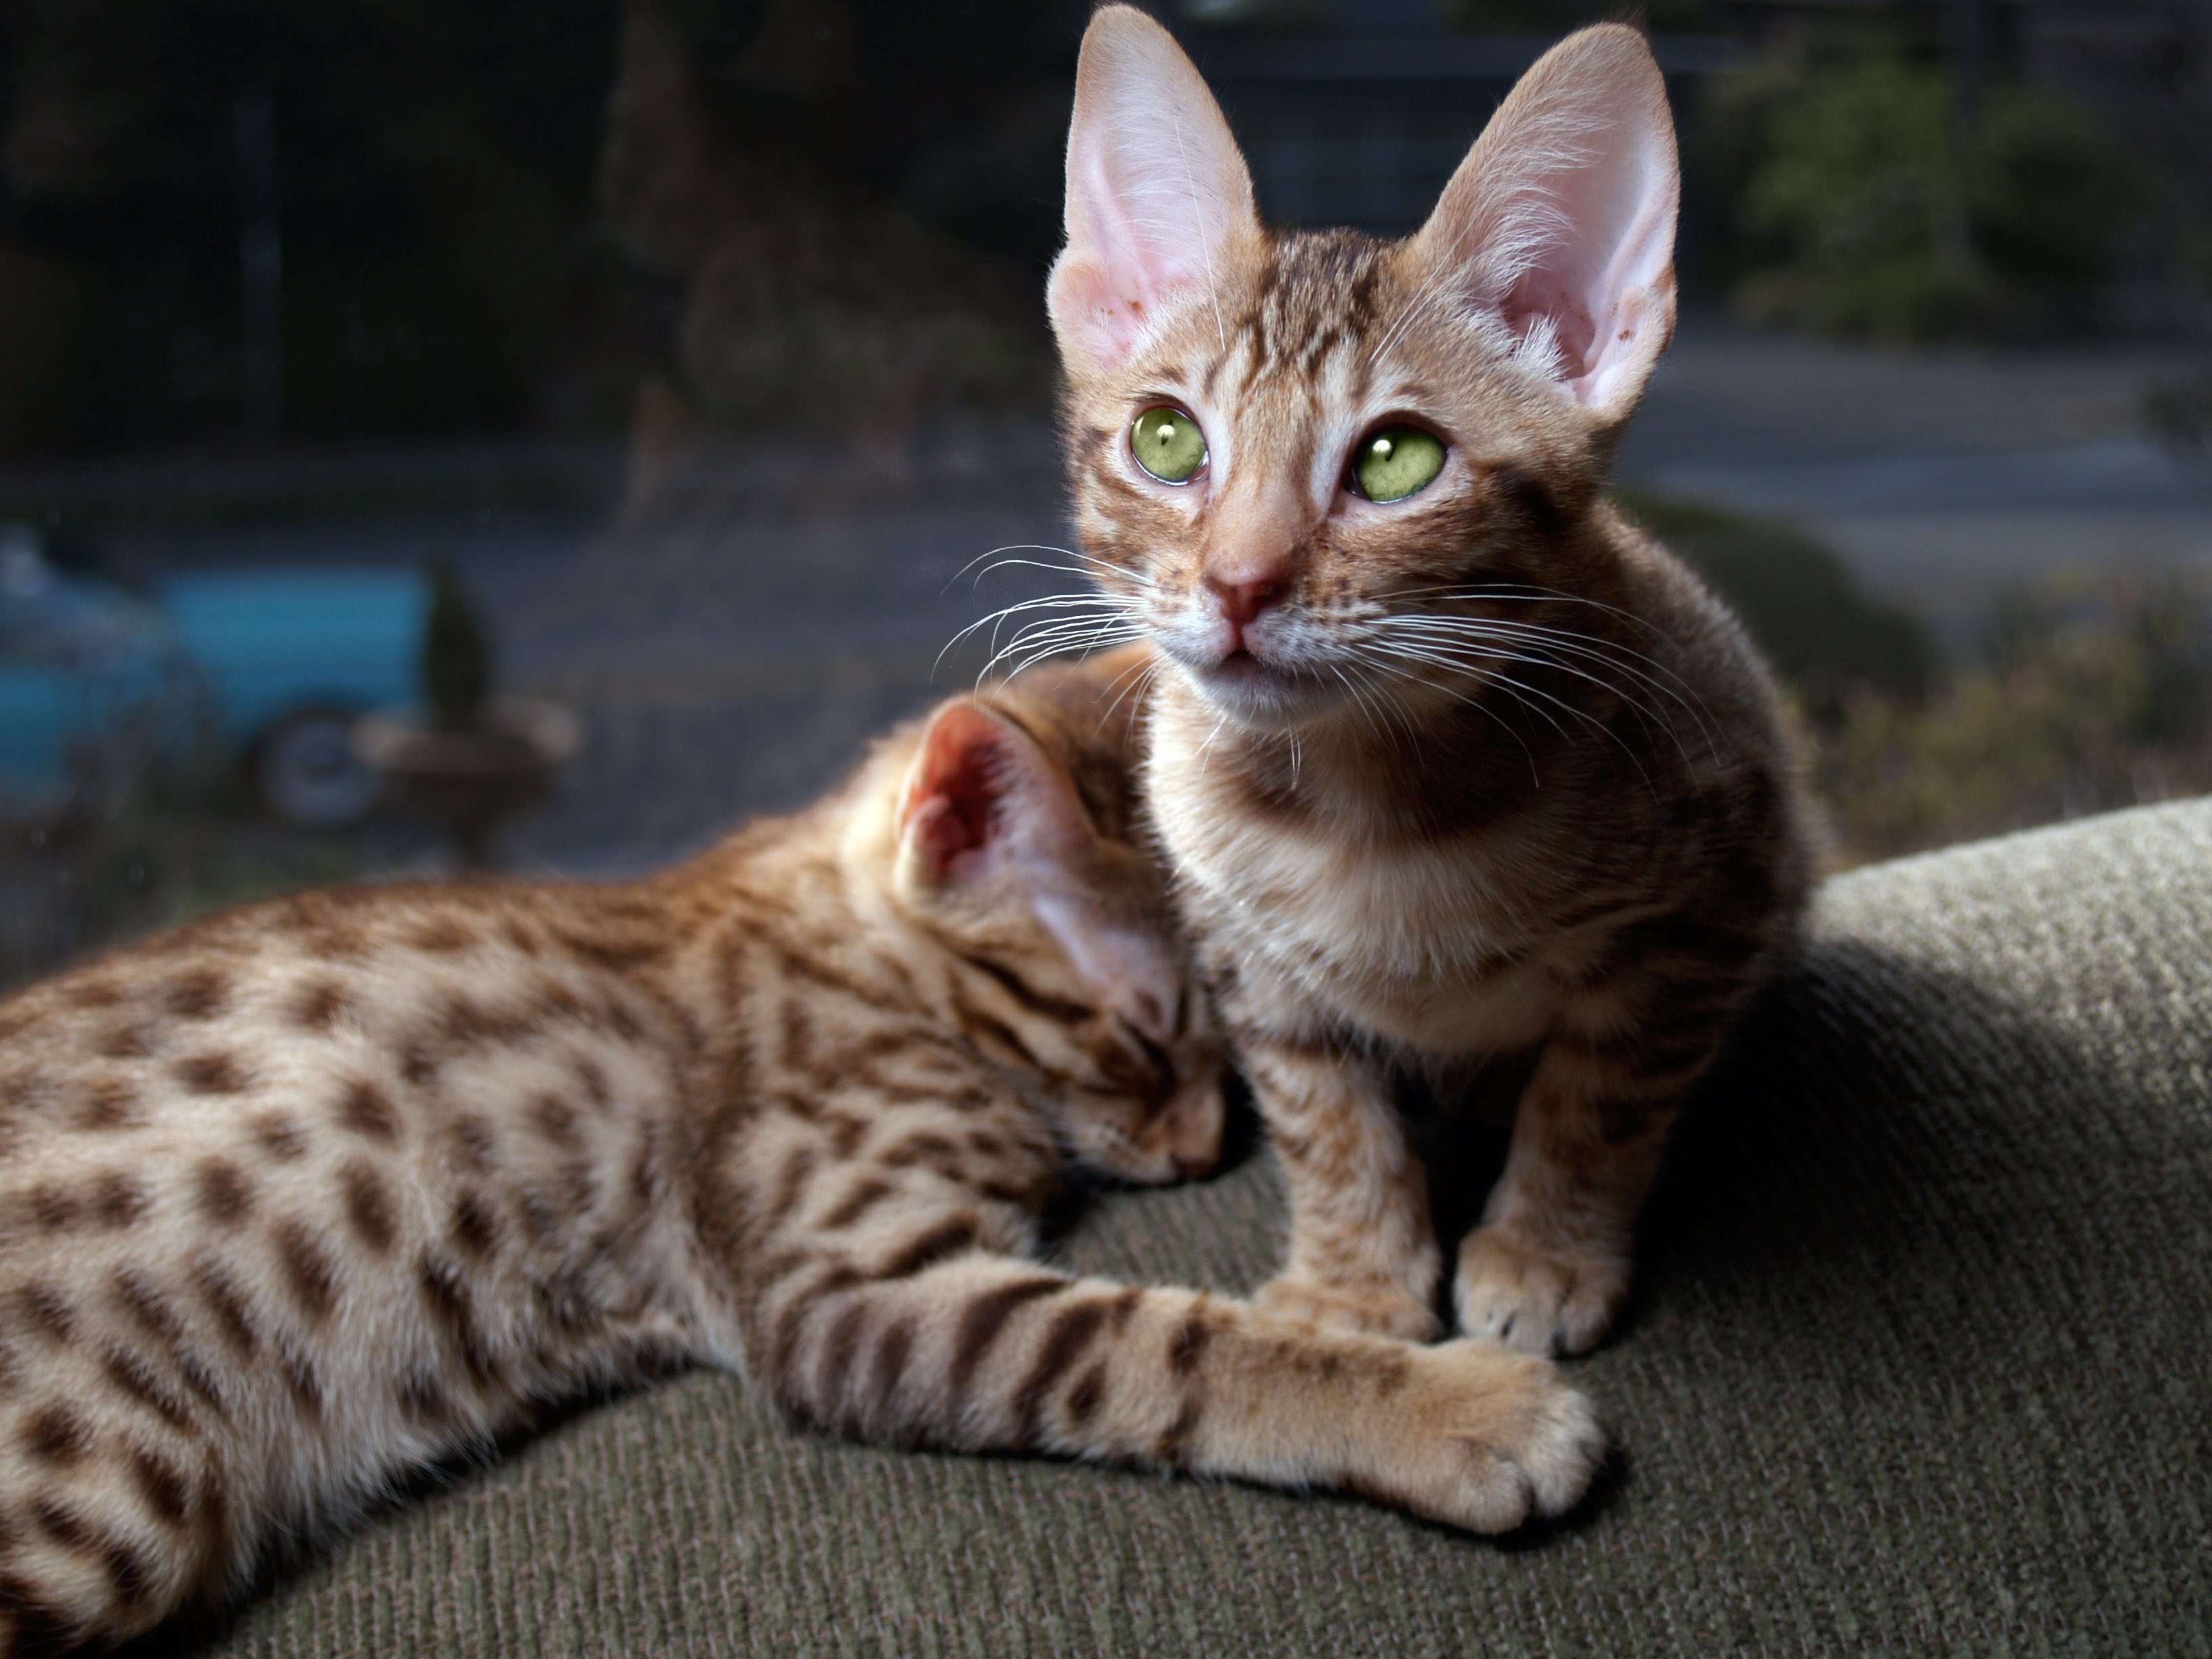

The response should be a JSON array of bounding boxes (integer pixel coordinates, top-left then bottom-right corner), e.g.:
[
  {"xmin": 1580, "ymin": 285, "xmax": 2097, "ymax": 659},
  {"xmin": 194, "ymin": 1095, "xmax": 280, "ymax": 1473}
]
[{"xmin": 0, "ymin": 659, "xmax": 1601, "ymax": 1652}]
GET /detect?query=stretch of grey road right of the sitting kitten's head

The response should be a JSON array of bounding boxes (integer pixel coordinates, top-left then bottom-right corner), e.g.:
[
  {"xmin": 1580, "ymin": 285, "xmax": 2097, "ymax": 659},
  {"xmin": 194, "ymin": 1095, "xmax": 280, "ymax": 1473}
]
[{"xmin": 1622, "ymin": 316, "xmax": 2212, "ymax": 619}]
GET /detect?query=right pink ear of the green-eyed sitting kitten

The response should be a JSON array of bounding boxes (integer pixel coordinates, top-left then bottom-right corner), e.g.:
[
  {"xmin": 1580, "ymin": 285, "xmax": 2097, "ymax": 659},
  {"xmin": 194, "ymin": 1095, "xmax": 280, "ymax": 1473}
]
[{"xmin": 1414, "ymin": 24, "xmax": 1681, "ymax": 425}]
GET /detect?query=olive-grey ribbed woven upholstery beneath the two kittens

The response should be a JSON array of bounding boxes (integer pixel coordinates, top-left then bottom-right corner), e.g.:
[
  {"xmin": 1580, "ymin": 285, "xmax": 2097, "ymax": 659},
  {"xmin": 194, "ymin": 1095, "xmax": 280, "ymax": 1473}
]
[{"xmin": 172, "ymin": 803, "xmax": 2212, "ymax": 1659}]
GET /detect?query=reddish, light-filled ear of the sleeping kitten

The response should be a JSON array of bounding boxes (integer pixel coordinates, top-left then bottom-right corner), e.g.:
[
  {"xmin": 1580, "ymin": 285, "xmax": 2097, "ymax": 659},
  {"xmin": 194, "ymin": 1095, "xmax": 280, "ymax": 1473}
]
[{"xmin": 898, "ymin": 701, "xmax": 1086, "ymax": 885}]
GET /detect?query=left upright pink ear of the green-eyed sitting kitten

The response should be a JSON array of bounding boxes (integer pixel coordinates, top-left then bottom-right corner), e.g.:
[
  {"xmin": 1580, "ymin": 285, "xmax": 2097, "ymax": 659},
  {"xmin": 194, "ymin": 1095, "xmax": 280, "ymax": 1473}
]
[{"xmin": 1044, "ymin": 7, "xmax": 1258, "ymax": 371}]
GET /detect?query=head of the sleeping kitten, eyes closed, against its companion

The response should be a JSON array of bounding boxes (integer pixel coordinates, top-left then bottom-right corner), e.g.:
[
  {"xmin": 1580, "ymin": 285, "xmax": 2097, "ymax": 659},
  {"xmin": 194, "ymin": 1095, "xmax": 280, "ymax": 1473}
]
[{"xmin": 862, "ymin": 663, "xmax": 1223, "ymax": 1181}]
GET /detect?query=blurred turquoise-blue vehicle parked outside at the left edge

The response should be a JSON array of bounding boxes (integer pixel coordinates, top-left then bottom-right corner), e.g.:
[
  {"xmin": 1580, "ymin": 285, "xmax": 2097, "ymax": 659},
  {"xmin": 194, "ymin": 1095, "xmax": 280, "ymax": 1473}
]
[{"xmin": 0, "ymin": 527, "xmax": 429, "ymax": 830}]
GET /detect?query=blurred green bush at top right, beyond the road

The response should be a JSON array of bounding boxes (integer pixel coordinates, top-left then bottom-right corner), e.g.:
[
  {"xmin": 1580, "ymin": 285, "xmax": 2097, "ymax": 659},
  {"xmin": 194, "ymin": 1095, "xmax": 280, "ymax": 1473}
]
[{"xmin": 1692, "ymin": 42, "xmax": 2148, "ymax": 338}]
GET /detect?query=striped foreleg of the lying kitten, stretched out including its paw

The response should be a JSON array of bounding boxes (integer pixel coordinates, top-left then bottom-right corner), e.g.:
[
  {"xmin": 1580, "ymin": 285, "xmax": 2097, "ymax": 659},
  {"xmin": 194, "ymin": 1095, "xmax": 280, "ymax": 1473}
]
[{"xmin": 750, "ymin": 1221, "xmax": 1603, "ymax": 1533}]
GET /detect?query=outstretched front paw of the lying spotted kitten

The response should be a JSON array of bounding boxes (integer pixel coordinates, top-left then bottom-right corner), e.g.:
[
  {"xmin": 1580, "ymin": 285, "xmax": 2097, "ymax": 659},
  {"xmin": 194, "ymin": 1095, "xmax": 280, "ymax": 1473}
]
[{"xmin": 1374, "ymin": 1340, "xmax": 1606, "ymax": 1533}]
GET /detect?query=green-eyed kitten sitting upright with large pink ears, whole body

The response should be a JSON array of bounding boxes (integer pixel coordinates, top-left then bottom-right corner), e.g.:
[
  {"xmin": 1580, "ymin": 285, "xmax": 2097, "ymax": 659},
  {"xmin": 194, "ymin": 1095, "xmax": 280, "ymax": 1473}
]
[{"xmin": 1050, "ymin": 7, "xmax": 1809, "ymax": 1351}]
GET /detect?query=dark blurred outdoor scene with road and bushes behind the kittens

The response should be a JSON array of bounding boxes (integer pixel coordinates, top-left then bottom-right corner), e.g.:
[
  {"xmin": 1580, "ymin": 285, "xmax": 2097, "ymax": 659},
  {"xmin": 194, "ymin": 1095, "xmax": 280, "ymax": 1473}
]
[{"xmin": 0, "ymin": 0, "xmax": 2212, "ymax": 982}]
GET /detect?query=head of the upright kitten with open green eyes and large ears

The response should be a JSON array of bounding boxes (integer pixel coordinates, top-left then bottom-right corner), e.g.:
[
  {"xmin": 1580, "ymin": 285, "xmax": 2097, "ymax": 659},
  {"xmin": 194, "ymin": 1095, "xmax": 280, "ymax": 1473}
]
[{"xmin": 1048, "ymin": 7, "xmax": 1677, "ymax": 728}]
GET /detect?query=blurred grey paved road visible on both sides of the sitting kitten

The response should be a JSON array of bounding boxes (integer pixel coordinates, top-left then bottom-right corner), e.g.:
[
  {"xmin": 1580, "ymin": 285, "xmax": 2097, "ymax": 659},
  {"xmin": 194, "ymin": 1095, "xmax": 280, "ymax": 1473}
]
[{"xmin": 112, "ymin": 319, "xmax": 2212, "ymax": 872}]
